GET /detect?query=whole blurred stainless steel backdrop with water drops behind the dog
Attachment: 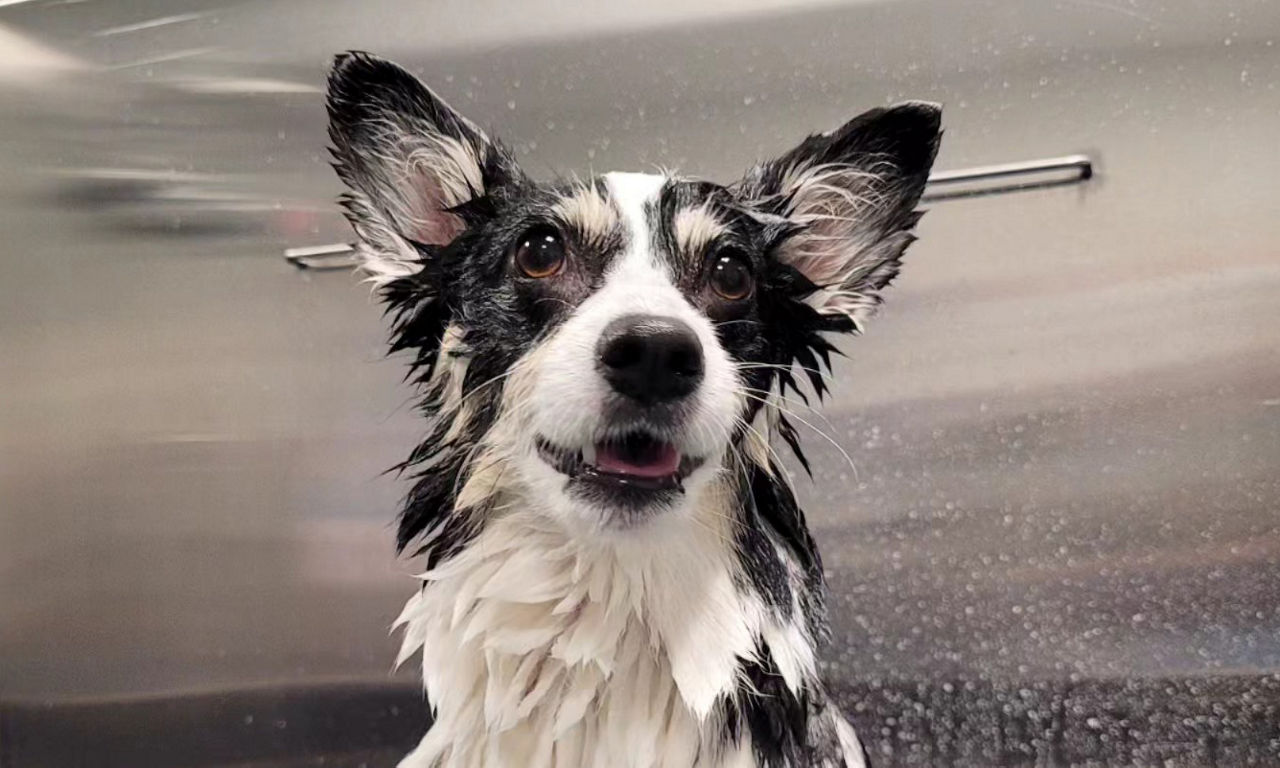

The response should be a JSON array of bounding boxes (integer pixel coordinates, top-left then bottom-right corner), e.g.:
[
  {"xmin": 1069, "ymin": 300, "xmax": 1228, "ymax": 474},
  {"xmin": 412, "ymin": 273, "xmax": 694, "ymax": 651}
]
[{"xmin": 0, "ymin": 0, "xmax": 1280, "ymax": 768}]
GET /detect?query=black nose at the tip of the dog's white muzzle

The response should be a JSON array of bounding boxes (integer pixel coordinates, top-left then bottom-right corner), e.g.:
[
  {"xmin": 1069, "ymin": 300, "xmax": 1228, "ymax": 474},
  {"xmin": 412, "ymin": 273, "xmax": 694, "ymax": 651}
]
[{"xmin": 596, "ymin": 315, "xmax": 703, "ymax": 404}]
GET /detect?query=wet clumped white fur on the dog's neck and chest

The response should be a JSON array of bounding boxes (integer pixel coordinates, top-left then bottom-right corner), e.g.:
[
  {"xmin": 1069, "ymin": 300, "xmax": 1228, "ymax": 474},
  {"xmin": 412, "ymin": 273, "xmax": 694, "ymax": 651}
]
[{"xmin": 399, "ymin": 481, "xmax": 814, "ymax": 768}]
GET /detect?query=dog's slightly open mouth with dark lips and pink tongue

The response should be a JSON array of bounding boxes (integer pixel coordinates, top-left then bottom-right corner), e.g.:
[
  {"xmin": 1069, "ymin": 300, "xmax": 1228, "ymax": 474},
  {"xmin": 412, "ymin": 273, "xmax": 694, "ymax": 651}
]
[{"xmin": 538, "ymin": 430, "xmax": 703, "ymax": 490}]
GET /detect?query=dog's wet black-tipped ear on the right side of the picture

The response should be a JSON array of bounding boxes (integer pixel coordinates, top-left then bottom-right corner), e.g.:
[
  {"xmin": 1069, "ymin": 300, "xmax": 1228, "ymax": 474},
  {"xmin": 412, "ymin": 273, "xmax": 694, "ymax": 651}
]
[{"xmin": 739, "ymin": 101, "xmax": 942, "ymax": 332}]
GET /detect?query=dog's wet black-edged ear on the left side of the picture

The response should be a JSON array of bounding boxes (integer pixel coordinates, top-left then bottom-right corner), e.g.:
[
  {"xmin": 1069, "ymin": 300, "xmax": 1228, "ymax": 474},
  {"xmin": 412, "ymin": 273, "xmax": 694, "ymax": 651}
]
[{"xmin": 328, "ymin": 52, "xmax": 524, "ymax": 284}]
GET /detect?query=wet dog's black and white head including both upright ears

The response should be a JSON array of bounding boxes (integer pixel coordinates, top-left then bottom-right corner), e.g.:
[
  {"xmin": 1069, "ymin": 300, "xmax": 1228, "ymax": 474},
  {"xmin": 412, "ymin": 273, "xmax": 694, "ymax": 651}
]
[{"xmin": 329, "ymin": 54, "xmax": 940, "ymax": 544}]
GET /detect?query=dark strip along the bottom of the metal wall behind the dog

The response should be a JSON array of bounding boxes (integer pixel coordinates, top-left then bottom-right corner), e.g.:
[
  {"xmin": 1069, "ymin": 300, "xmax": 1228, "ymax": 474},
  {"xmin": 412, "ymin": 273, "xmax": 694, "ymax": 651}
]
[{"xmin": 0, "ymin": 676, "xmax": 1280, "ymax": 768}]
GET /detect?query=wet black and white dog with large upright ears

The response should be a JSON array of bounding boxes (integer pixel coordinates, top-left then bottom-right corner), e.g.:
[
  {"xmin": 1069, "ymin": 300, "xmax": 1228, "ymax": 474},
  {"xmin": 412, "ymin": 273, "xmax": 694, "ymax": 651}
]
[{"xmin": 328, "ymin": 52, "xmax": 941, "ymax": 768}]
